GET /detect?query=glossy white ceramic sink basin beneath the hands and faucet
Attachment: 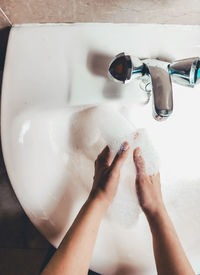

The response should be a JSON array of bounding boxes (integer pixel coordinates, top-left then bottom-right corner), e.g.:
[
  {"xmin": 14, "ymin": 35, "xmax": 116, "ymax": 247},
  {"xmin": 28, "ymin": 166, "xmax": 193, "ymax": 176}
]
[{"xmin": 1, "ymin": 24, "xmax": 200, "ymax": 275}]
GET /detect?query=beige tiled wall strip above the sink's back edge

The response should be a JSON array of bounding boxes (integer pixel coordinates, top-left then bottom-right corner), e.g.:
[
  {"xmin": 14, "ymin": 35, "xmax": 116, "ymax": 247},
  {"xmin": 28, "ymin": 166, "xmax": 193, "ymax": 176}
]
[{"xmin": 0, "ymin": 0, "xmax": 200, "ymax": 26}]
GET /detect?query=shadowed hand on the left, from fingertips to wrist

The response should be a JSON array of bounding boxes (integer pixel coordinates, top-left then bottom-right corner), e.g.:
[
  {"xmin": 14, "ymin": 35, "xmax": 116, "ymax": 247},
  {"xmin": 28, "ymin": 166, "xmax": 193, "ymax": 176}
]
[{"xmin": 90, "ymin": 142, "xmax": 129, "ymax": 206}]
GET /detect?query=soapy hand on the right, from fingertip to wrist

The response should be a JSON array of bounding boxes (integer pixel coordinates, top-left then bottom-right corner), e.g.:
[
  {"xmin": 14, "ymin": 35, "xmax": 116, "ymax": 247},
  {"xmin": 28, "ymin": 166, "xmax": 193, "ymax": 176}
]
[{"xmin": 133, "ymin": 148, "xmax": 164, "ymax": 215}]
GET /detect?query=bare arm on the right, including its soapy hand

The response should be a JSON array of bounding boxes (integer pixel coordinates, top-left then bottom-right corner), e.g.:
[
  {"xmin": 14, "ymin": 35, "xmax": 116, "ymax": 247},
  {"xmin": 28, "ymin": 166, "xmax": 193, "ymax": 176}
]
[{"xmin": 134, "ymin": 148, "xmax": 195, "ymax": 275}]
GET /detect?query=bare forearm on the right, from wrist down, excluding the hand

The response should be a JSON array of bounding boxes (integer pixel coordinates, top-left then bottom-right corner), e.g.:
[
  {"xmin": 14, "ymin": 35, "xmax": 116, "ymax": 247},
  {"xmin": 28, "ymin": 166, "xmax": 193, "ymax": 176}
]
[{"xmin": 147, "ymin": 205, "xmax": 195, "ymax": 275}]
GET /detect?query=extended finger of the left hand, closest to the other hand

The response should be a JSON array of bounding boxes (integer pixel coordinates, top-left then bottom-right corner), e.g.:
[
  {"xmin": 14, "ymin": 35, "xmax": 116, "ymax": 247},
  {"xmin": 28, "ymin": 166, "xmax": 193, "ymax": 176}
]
[{"xmin": 110, "ymin": 142, "xmax": 129, "ymax": 171}]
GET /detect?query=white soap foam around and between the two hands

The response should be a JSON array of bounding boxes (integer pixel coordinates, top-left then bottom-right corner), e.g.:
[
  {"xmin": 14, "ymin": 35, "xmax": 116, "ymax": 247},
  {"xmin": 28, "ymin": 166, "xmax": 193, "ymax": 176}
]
[{"xmin": 96, "ymin": 106, "xmax": 159, "ymax": 227}]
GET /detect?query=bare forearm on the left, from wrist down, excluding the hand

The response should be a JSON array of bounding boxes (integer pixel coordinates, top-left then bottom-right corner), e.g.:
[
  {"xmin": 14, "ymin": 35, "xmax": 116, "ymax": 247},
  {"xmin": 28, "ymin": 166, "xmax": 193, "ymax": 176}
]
[{"xmin": 42, "ymin": 198, "xmax": 107, "ymax": 275}]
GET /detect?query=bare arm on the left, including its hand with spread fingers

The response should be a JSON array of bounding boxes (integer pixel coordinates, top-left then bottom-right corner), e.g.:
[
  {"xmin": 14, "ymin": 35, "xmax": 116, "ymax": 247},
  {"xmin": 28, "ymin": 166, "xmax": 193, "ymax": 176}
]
[{"xmin": 42, "ymin": 143, "xmax": 128, "ymax": 275}]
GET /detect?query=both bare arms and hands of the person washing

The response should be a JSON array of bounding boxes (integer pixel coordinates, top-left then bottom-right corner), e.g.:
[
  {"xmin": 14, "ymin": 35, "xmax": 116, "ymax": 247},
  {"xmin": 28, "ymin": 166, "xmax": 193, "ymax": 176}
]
[{"xmin": 42, "ymin": 142, "xmax": 195, "ymax": 275}]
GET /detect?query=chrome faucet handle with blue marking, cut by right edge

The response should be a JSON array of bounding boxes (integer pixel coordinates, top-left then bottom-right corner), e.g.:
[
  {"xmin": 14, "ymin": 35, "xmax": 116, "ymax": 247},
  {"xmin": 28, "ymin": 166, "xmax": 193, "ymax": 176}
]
[{"xmin": 168, "ymin": 57, "xmax": 200, "ymax": 87}]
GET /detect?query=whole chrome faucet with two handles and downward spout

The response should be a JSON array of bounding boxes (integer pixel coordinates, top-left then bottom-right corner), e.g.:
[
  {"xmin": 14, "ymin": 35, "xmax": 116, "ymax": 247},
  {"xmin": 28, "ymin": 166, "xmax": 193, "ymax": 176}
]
[{"xmin": 108, "ymin": 53, "xmax": 200, "ymax": 121}]
